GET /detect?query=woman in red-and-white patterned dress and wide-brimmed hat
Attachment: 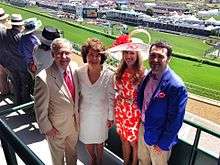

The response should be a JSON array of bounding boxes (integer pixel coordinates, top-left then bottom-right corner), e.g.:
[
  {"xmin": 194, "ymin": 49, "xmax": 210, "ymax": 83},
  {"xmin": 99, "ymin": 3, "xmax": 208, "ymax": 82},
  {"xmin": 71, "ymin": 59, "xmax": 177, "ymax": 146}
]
[{"xmin": 107, "ymin": 34, "xmax": 148, "ymax": 165}]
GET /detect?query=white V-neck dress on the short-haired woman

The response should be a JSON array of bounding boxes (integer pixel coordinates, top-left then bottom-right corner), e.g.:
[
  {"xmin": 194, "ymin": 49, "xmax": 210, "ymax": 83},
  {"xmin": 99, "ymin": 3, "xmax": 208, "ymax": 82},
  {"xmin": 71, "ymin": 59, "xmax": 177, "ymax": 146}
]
[{"xmin": 77, "ymin": 64, "xmax": 114, "ymax": 144}]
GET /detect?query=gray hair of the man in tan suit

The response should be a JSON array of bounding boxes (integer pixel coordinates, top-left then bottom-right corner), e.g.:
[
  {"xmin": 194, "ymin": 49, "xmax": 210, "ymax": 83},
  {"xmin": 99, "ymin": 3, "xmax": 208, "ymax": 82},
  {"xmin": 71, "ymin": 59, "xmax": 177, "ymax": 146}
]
[{"xmin": 50, "ymin": 38, "xmax": 73, "ymax": 53}]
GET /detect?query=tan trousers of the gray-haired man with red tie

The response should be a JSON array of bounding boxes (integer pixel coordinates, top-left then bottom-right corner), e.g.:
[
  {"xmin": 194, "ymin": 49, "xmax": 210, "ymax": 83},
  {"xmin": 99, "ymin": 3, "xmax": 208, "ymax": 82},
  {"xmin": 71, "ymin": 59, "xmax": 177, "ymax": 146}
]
[{"xmin": 47, "ymin": 127, "xmax": 79, "ymax": 165}]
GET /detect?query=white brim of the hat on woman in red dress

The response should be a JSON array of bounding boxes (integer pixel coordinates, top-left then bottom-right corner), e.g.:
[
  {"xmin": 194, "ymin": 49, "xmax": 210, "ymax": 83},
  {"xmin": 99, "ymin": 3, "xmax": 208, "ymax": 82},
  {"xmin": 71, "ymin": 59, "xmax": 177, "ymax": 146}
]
[{"xmin": 104, "ymin": 43, "xmax": 150, "ymax": 60}]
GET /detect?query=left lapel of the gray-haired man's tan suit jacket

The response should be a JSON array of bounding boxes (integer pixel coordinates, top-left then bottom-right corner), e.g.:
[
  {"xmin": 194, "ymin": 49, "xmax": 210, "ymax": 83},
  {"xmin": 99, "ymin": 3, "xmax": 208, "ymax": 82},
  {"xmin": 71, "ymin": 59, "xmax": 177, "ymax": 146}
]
[{"xmin": 51, "ymin": 63, "xmax": 73, "ymax": 102}]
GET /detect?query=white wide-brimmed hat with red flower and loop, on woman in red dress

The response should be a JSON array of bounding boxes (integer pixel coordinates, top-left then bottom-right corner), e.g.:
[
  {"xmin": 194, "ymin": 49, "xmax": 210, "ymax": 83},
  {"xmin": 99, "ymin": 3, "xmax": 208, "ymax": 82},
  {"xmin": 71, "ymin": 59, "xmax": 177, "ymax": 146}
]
[{"xmin": 105, "ymin": 29, "xmax": 151, "ymax": 60}]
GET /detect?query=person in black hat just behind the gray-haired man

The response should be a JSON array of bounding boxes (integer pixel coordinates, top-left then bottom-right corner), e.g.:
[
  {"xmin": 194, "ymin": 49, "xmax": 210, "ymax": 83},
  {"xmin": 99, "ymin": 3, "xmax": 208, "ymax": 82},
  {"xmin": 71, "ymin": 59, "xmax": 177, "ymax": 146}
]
[{"xmin": 34, "ymin": 26, "xmax": 61, "ymax": 74}]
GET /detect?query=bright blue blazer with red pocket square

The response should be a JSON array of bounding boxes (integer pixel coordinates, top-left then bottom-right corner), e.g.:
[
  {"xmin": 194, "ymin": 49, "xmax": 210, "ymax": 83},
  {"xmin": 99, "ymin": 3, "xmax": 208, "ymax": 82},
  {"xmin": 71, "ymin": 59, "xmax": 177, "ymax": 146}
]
[{"xmin": 138, "ymin": 68, "xmax": 188, "ymax": 150}]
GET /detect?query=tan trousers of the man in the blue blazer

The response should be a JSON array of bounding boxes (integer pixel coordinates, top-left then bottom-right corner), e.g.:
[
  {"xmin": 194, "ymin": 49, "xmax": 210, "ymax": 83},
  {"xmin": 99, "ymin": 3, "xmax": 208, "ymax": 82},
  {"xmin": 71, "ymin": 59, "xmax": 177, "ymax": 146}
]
[{"xmin": 138, "ymin": 124, "xmax": 171, "ymax": 165}]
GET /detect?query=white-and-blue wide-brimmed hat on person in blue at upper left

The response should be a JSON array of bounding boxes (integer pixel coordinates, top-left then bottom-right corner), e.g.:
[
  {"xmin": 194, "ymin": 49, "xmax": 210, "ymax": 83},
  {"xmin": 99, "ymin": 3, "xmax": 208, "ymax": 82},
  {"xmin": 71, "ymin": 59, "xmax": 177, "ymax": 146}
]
[{"xmin": 22, "ymin": 18, "xmax": 42, "ymax": 35}]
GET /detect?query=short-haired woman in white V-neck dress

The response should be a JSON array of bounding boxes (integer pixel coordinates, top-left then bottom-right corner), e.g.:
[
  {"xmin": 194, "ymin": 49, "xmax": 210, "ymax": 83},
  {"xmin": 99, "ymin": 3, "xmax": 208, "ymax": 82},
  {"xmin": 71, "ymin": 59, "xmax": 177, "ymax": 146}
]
[{"xmin": 77, "ymin": 38, "xmax": 114, "ymax": 165}]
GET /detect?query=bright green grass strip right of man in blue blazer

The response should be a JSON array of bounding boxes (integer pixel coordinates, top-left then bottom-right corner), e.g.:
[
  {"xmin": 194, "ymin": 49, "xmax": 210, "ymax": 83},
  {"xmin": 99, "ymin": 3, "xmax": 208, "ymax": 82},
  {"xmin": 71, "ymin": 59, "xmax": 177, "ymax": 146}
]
[{"xmin": 145, "ymin": 57, "xmax": 220, "ymax": 100}]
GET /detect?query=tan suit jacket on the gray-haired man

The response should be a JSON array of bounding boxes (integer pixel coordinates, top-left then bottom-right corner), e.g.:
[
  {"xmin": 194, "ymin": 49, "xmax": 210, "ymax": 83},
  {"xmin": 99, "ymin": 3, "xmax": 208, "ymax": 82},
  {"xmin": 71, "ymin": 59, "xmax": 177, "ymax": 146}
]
[{"xmin": 34, "ymin": 62, "xmax": 79, "ymax": 136}]
